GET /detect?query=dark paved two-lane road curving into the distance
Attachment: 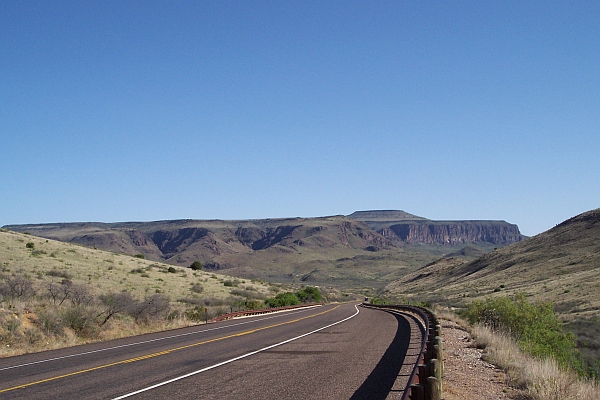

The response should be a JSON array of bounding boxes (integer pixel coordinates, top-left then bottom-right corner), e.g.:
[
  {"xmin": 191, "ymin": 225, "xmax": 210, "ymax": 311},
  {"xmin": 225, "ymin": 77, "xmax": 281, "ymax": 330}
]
[{"xmin": 0, "ymin": 304, "xmax": 420, "ymax": 400}]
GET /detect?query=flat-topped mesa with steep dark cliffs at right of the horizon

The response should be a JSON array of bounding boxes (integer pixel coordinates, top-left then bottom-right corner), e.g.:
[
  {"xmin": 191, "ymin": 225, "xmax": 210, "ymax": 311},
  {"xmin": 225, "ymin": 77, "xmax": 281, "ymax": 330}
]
[{"xmin": 348, "ymin": 210, "xmax": 525, "ymax": 246}]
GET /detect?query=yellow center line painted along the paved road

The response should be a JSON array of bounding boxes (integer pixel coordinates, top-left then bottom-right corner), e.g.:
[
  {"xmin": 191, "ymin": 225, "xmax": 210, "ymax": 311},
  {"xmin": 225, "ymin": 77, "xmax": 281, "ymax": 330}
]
[{"xmin": 0, "ymin": 305, "xmax": 340, "ymax": 393}]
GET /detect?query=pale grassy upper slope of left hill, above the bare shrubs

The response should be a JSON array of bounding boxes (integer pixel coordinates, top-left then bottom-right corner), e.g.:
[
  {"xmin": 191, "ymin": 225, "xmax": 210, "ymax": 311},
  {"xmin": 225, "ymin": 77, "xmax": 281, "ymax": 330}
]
[{"xmin": 0, "ymin": 231, "xmax": 271, "ymax": 310}]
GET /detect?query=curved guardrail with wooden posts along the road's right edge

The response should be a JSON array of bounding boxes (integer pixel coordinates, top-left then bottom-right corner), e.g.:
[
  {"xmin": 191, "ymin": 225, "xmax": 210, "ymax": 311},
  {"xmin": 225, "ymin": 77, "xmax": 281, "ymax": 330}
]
[{"xmin": 363, "ymin": 303, "xmax": 444, "ymax": 400}]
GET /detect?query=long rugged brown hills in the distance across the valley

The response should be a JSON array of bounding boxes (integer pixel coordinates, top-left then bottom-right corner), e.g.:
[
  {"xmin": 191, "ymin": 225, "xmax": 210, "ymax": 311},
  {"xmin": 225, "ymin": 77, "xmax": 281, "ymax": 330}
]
[{"xmin": 5, "ymin": 211, "xmax": 518, "ymax": 287}]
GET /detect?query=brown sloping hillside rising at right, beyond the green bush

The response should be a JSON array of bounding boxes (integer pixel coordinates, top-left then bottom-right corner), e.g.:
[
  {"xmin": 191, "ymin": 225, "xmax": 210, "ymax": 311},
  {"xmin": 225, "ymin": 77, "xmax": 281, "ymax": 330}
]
[{"xmin": 386, "ymin": 209, "xmax": 600, "ymax": 368}]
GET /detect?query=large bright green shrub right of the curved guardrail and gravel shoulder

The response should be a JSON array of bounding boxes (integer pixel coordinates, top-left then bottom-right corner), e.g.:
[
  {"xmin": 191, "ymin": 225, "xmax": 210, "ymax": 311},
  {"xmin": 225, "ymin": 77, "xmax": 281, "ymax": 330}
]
[{"xmin": 462, "ymin": 295, "xmax": 582, "ymax": 371}]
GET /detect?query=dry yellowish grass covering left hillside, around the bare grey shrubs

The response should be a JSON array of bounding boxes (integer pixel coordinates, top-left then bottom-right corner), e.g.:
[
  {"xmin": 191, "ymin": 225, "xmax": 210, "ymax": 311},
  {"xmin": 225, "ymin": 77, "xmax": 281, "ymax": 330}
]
[{"xmin": 0, "ymin": 230, "xmax": 278, "ymax": 357}]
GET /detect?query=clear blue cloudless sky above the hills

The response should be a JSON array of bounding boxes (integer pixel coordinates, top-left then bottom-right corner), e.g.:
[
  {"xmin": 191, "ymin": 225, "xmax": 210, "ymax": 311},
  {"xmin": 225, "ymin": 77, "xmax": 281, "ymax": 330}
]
[{"xmin": 0, "ymin": 0, "xmax": 600, "ymax": 235}]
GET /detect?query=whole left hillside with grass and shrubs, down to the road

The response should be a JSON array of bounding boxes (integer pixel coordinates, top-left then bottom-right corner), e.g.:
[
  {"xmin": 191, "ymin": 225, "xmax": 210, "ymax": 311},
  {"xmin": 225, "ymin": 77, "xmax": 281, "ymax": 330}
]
[{"xmin": 0, "ymin": 230, "xmax": 280, "ymax": 357}]
